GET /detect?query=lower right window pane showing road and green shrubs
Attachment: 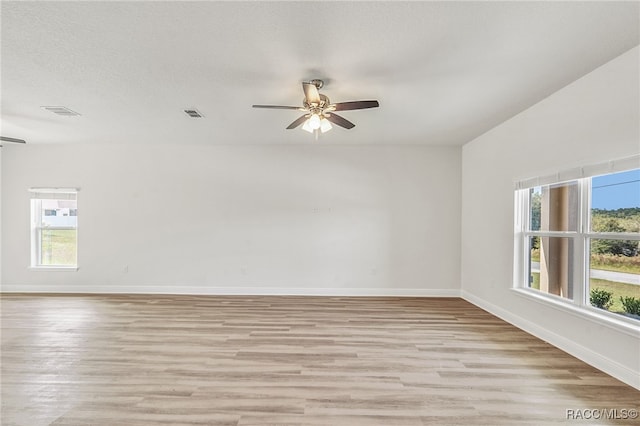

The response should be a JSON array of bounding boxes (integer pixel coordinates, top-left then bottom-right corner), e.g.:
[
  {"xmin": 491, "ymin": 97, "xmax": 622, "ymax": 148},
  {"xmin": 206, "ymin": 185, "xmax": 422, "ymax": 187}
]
[{"xmin": 589, "ymin": 239, "xmax": 640, "ymax": 319}]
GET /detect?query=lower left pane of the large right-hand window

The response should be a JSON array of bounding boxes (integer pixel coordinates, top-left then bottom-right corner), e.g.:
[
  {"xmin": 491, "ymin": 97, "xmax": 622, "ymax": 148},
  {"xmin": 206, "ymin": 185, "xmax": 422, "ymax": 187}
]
[{"xmin": 529, "ymin": 237, "xmax": 573, "ymax": 299}]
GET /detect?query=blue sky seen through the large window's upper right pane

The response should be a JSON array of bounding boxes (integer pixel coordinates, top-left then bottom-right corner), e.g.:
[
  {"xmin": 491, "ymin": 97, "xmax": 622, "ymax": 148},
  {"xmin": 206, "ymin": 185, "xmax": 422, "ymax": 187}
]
[{"xmin": 591, "ymin": 169, "xmax": 640, "ymax": 210}]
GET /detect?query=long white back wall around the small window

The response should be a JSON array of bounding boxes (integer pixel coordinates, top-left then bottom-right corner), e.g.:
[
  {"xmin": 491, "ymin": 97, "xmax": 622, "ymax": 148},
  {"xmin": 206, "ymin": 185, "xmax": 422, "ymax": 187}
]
[{"xmin": 2, "ymin": 143, "xmax": 461, "ymax": 295}]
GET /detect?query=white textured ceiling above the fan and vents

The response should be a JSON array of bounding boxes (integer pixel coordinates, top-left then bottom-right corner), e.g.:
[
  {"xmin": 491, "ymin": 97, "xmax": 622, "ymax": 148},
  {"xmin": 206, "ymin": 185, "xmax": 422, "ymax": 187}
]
[{"xmin": 0, "ymin": 1, "xmax": 640, "ymax": 145}]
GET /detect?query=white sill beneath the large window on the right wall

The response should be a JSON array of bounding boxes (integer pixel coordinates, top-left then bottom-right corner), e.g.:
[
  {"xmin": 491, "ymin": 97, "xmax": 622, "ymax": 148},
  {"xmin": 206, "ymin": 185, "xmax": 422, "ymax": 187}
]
[{"xmin": 511, "ymin": 288, "xmax": 640, "ymax": 338}]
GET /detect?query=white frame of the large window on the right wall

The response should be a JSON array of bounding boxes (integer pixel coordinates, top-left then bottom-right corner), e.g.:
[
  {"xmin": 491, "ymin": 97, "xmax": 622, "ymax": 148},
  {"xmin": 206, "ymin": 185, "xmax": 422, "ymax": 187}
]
[{"xmin": 513, "ymin": 156, "xmax": 640, "ymax": 333}]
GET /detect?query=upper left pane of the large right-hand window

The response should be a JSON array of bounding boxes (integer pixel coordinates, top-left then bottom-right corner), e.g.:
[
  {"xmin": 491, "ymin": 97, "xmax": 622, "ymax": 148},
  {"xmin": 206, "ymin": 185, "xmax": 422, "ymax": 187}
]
[{"xmin": 529, "ymin": 181, "xmax": 580, "ymax": 231}]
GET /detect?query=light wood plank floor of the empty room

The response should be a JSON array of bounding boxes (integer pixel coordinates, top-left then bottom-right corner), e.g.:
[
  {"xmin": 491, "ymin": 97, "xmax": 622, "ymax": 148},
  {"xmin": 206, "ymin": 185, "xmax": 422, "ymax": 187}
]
[{"xmin": 0, "ymin": 294, "xmax": 640, "ymax": 426}]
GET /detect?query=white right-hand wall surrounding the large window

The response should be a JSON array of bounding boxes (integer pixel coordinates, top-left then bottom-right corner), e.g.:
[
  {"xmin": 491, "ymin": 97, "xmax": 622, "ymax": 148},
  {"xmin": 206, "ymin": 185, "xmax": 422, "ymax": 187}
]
[{"xmin": 462, "ymin": 47, "xmax": 640, "ymax": 387}]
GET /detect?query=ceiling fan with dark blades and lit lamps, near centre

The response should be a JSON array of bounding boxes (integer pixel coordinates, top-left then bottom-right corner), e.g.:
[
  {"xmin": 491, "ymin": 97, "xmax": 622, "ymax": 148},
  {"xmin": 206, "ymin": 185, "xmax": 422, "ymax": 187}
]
[{"xmin": 253, "ymin": 79, "xmax": 380, "ymax": 136}]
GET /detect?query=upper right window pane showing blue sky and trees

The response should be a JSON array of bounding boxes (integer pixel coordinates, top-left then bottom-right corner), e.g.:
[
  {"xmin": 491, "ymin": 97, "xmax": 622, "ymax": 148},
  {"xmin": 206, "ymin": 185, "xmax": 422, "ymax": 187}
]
[{"xmin": 591, "ymin": 169, "xmax": 640, "ymax": 232}]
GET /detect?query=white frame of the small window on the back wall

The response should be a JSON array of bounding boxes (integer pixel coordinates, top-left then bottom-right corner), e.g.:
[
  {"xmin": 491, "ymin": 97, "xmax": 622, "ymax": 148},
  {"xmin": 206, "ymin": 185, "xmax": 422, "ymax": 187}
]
[{"xmin": 29, "ymin": 188, "xmax": 79, "ymax": 271}]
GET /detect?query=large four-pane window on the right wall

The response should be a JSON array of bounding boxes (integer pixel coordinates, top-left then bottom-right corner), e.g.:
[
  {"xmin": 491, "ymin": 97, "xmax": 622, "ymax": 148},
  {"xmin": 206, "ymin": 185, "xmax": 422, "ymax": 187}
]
[{"xmin": 514, "ymin": 161, "xmax": 640, "ymax": 321}]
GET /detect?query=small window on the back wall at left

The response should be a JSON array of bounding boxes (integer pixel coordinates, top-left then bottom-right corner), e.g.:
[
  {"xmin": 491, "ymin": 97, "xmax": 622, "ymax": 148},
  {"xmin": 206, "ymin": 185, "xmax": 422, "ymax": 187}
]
[{"xmin": 30, "ymin": 188, "xmax": 78, "ymax": 269}]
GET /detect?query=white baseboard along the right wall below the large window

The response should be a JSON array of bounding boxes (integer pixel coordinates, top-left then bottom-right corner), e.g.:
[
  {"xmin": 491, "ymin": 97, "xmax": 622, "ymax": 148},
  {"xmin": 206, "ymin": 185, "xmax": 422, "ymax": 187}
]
[{"xmin": 461, "ymin": 290, "xmax": 640, "ymax": 390}]
